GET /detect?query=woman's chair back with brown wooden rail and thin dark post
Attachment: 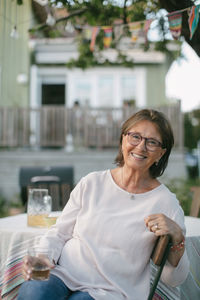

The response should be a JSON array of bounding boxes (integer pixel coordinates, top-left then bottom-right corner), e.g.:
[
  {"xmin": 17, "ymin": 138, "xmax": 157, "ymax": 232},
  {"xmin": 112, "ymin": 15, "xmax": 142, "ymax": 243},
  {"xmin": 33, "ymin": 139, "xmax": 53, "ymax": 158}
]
[{"xmin": 147, "ymin": 235, "xmax": 171, "ymax": 300}]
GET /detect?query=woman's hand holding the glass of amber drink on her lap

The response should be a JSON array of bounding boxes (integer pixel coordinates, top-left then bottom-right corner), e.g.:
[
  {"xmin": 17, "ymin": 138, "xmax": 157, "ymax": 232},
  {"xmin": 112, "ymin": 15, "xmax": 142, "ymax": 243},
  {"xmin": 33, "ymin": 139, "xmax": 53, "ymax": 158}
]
[{"xmin": 22, "ymin": 255, "xmax": 55, "ymax": 280}]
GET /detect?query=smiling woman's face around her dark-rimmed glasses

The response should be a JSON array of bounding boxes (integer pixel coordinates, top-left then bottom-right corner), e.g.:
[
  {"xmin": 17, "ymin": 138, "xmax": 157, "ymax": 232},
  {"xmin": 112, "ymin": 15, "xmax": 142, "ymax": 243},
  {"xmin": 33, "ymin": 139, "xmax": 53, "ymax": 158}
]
[{"xmin": 122, "ymin": 120, "xmax": 166, "ymax": 171}]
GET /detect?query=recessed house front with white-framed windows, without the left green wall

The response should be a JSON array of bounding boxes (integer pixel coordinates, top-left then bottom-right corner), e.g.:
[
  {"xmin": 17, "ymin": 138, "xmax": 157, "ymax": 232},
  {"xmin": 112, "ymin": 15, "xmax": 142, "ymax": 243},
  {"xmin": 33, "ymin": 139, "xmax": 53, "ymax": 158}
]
[{"xmin": 30, "ymin": 38, "xmax": 170, "ymax": 107}]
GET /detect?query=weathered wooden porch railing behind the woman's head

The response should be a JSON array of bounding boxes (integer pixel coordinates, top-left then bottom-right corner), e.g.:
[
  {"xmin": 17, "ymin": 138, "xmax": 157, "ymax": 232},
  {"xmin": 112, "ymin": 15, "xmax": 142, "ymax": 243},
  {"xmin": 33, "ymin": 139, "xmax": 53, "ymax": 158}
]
[{"xmin": 0, "ymin": 103, "xmax": 183, "ymax": 149}]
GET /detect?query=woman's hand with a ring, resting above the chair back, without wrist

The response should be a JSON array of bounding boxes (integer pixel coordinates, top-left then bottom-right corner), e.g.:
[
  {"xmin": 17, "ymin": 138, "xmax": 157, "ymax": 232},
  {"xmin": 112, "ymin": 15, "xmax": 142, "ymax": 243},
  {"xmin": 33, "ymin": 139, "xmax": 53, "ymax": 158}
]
[{"xmin": 145, "ymin": 214, "xmax": 183, "ymax": 244}]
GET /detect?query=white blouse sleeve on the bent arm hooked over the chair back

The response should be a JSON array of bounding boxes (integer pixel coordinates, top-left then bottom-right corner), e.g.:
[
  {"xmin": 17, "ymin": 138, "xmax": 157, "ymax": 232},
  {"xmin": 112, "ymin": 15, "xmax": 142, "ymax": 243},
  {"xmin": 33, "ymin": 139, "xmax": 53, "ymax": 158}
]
[{"xmin": 161, "ymin": 207, "xmax": 189, "ymax": 287}]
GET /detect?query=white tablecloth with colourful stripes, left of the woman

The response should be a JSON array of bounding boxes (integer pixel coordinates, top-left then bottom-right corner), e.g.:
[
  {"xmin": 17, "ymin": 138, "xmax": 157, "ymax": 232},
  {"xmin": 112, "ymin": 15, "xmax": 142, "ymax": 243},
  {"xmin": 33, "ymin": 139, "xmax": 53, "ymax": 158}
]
[{"xmin": 0, "ymin": 214, "xmax": 47, "ymax": 300}]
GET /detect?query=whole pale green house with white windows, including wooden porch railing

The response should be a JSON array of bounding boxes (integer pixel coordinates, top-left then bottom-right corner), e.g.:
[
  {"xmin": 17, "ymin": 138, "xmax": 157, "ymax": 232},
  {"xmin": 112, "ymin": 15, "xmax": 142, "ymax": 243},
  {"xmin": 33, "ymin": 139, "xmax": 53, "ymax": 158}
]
[{"xmin": 0, "ymin": 0, "xmax": 183, "ymax": 148}]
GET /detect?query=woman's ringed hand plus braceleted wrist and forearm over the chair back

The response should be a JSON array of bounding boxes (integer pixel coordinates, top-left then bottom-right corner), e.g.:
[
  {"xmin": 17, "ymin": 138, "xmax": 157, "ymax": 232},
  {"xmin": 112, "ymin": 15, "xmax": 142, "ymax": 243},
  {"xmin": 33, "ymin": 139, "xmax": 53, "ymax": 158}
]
[{"xmin": 145, "ymin": 214, "xmax": 184, "ymax": 267}]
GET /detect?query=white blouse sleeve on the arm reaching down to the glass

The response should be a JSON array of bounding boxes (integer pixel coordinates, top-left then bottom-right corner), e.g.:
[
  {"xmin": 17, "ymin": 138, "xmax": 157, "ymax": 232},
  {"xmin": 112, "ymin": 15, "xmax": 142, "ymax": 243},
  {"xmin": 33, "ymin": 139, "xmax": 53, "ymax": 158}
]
[{"xmin": 40, "ymin": 179, "xmax": 84, "ymax": 263}]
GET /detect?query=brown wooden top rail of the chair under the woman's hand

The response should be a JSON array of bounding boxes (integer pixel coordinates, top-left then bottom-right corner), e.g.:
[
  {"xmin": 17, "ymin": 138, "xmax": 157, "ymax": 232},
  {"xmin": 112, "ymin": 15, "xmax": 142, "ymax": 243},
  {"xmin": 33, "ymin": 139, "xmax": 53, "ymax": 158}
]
[{"xmin": 151, "ymin": 235, "xmax": 171, "ymax": 266}]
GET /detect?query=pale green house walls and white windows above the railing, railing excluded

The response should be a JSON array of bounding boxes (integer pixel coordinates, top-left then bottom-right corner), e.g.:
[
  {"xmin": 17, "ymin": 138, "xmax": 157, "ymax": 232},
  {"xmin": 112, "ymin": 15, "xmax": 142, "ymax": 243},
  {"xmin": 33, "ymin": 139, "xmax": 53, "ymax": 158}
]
[{"xmin": 0, "ymin": 0, "xmax": 175, "ymax": 108}]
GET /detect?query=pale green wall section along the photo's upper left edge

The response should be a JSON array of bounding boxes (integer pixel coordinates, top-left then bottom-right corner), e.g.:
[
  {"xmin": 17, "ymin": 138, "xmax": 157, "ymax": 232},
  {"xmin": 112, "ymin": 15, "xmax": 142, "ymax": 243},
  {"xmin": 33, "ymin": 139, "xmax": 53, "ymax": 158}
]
[{"xmin": 0, "ymin": 0, "xmax": 32, "ymax": 106}]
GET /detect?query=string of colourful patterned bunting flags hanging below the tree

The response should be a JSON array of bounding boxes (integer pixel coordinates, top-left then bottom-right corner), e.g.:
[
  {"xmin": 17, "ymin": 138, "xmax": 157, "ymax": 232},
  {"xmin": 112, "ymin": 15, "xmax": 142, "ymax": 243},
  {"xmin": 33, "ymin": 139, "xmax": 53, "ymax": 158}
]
[{"xmin": 63, "ymin": 4, "xmax": 200, "ymax": 51}]
